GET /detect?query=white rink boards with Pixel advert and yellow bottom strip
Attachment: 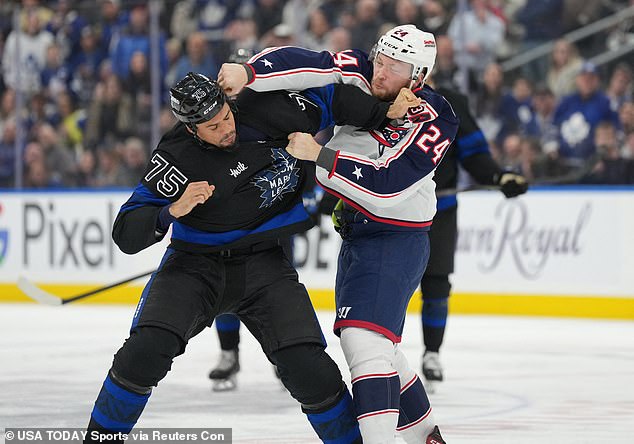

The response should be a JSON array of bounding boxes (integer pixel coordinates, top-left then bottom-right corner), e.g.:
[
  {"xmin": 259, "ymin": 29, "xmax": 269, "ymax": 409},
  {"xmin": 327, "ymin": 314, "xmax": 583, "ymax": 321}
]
[{"xmin": 0, "ymin": 187, "xmax": 634, "ymax": 319}]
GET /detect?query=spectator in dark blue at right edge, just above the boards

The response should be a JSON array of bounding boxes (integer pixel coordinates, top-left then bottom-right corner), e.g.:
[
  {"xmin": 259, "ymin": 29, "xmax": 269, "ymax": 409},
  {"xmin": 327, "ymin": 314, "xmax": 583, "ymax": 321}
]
[{"xmin": 581, "ymin": 121, "xmax": 634, "ymax": 185}]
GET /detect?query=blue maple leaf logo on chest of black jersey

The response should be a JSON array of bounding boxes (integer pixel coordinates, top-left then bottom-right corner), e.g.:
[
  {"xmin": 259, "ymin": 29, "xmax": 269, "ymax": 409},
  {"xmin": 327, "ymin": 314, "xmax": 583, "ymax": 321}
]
[{"xmin": 253, "ymin": 148, "xmax": 299, "ymax": 208}]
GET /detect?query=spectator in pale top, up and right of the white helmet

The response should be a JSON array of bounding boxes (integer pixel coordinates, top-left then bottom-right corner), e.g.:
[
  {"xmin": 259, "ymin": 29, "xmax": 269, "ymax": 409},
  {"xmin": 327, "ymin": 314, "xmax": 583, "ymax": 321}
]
[{"xmin": 448, "ymin": 0, "xmax": 506, "ymax": 89}]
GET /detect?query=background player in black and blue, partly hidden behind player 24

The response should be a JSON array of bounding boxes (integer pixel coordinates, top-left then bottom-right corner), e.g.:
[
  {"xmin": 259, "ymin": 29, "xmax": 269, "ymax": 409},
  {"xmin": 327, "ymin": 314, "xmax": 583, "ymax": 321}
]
[{"xmin": 421, "ymin": 80, "xmax": 528, "ymax": 390}]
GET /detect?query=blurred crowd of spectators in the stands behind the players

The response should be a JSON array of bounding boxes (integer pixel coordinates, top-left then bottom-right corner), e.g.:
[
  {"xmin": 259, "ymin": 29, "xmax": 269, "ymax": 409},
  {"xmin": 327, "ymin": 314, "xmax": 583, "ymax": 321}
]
[{"xmin": 0, "ymin": 0, "xmax": 634, "ymax": 188}]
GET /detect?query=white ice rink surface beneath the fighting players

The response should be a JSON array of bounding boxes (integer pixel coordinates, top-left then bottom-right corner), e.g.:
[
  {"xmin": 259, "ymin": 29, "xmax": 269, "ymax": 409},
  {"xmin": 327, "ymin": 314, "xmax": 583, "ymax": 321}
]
[{"xmin": 0, "ymin": 304, "xmax": 634, "ymax": 444}]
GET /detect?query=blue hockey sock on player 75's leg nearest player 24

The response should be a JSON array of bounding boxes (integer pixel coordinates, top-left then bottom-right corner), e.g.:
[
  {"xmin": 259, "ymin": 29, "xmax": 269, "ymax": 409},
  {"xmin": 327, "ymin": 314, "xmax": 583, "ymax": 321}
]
[{"xmin": 304, "ymin": 389, "xmax": 362, "ymax": 444}]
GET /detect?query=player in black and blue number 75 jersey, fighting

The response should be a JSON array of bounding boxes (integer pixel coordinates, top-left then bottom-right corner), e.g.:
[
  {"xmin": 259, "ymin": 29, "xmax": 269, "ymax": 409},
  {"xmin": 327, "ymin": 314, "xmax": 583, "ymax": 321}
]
[{"xmin": 85, "ymin": 73, "xmax": 409, "ymax": 443}]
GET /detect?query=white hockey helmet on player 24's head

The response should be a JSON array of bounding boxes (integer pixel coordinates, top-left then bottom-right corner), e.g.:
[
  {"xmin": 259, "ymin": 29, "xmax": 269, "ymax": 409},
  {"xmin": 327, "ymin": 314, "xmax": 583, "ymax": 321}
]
[{"xmin": 370, "ymin": 25, "xmax": 436, "ymax": 81}]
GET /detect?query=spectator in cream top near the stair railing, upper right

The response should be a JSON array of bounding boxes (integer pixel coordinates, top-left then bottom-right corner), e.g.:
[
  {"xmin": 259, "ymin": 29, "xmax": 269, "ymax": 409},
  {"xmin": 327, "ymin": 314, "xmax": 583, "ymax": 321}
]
[{"xmin": 546, "ymin": 39, "xmax": 583, "ymax": 99}]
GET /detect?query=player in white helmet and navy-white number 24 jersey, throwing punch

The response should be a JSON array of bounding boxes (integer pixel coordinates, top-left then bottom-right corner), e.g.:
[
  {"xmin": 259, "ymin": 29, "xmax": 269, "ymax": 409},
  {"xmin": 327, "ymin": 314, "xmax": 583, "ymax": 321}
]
[{"xmin": 218, "ymin": 25, "xmax": 458, "ymax": 444}]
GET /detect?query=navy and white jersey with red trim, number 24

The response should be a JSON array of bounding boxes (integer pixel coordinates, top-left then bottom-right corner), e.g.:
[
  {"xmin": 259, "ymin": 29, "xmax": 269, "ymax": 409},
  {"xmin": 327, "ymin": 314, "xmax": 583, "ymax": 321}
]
[{"xmin": 247, "ymin": 47, "xmax": 458, "ymax": 229}]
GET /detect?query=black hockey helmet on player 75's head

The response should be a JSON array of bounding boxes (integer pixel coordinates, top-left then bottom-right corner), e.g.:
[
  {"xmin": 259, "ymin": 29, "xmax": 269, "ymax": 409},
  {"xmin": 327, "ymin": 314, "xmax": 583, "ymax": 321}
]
[{"xmin": 170, "ymin": 72, "xmax": 227, "ymax": 129}]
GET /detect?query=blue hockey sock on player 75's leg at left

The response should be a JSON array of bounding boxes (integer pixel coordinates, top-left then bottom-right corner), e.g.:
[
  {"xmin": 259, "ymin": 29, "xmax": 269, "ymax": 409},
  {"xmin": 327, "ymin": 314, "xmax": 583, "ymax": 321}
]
[{"xmin": 89, "ymin": 375, "xmax": 151, "ymax": 433}]
